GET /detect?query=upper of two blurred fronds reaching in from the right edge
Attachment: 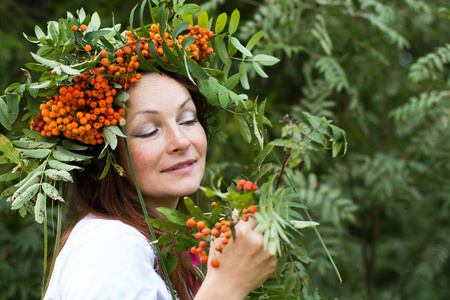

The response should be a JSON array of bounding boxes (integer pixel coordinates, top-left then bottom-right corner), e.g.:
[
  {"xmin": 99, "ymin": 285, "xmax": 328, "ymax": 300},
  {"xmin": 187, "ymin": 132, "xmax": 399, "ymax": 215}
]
[{"xmin": 408, "ymin": 44, "xmax": 450, "ymax": 83}]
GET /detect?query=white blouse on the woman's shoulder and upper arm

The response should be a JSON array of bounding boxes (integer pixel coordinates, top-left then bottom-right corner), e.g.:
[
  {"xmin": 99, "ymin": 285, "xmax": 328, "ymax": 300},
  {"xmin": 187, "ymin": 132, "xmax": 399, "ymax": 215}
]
[{"xmin": 44, "ymin": 215, "xmax": 172, "ymax": 300}]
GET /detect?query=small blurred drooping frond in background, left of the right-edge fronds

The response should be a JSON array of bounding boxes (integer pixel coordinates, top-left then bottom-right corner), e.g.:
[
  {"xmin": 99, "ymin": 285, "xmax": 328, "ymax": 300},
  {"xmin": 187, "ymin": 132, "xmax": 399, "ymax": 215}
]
[{"xmin": 315, "ymin": 56, "xmax": 349, "ymax": 92}]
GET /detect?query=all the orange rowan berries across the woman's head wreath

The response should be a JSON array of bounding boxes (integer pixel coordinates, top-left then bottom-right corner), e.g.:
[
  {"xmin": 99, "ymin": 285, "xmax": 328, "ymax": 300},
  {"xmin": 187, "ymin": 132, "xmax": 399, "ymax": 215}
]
[{"xmin": 30, "ymin": 24, "xmax": 214, "ymax": 145}]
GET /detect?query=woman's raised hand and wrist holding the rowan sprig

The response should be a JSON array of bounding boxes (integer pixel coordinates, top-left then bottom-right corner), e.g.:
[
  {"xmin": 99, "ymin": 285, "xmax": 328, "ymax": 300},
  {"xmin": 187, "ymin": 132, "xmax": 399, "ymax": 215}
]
[{"xmin": 195, "ymin": 216, "xmax": 276, "ymax": 299}]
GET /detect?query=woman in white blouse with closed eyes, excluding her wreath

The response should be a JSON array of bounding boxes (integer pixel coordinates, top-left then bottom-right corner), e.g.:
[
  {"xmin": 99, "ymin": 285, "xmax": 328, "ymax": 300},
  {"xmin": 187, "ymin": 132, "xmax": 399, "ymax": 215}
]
[{"xmin": 44, "ymin": 69, "xmax": 276, "ymax": 300}]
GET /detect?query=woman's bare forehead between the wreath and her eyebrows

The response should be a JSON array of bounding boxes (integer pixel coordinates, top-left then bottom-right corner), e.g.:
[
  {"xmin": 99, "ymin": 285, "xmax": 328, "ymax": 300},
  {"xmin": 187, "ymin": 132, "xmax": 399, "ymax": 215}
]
[{"xmin": 126, "ymin": 73, "xmax": 190, "ymax": 111}]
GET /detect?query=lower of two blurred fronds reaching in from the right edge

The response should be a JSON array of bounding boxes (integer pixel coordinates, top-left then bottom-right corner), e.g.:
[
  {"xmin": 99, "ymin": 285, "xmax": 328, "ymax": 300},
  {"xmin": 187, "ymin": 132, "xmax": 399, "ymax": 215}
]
[{"xmin": 391, "ymin": 91, "xmax": 450, "ymax": 136}]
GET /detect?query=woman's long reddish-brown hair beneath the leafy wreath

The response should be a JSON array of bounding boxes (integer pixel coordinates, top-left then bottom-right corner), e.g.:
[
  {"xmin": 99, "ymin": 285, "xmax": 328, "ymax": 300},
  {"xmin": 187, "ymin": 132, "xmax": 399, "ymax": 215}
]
[{"xmin": 62, "ymin": 71, "xmax": 206, "ymax": 300}]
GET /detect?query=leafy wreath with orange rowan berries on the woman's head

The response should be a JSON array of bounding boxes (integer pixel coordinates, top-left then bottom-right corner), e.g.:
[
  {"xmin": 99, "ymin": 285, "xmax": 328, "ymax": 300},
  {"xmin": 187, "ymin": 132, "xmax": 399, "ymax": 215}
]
[{"xmin": 0, "ymin": 0, "xmax": 278, "ymax": 218}]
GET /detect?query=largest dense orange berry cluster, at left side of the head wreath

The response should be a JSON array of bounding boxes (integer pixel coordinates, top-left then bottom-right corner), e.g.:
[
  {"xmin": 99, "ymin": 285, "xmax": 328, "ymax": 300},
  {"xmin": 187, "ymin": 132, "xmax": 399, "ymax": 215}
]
[{"xmin": 30, "ymin": 68, "xmax": 124, "ymax": 145}]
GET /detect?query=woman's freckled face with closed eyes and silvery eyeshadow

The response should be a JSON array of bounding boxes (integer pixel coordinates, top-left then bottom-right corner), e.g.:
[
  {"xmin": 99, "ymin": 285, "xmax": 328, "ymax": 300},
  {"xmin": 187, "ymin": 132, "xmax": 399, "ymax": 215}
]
[{"xmin": 119, "ymin": 73, "xmax": 207, "ymax": 208}]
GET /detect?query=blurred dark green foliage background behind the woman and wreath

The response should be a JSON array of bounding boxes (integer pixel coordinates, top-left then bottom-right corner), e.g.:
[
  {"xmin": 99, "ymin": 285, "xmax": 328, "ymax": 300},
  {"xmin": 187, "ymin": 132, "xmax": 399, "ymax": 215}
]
[{"xmin": 0, "ymin": 0, "xmax": 450, "ymax": 299}]
